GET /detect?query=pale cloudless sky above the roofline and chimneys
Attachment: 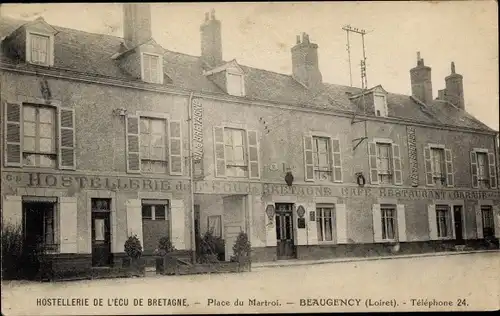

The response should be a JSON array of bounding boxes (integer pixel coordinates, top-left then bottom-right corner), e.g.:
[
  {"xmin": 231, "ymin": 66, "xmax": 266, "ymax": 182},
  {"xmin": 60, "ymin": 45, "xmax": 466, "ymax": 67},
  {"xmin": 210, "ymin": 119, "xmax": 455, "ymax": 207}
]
[{"xmin": 2, "ymin": 1, "xmax": 499, "ymax": 131}]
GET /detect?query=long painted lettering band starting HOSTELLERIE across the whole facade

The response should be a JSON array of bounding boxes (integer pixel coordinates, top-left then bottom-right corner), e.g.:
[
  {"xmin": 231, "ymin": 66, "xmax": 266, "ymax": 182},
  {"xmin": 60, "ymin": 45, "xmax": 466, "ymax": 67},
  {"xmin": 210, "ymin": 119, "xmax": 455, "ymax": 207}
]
[{"xmin": 2, "ymin": 171, "xmax": 500, "ymax": 200}]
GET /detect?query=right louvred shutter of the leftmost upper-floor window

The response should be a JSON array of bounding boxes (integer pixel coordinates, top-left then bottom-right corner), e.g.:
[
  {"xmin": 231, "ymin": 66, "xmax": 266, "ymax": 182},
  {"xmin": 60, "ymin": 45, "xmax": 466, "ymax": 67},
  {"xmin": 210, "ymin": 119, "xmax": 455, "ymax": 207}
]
[{"xmin": 58, "ymin": 107, "xmax": 76, "ymax": 170}]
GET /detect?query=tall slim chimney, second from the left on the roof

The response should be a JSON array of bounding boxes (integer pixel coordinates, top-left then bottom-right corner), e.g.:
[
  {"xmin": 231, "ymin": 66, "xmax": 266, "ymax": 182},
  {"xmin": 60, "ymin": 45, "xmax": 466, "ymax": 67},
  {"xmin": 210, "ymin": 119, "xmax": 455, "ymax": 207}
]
[{"xmin": 200, "ymin": 10, "xmax": 222, "ymax": 67}]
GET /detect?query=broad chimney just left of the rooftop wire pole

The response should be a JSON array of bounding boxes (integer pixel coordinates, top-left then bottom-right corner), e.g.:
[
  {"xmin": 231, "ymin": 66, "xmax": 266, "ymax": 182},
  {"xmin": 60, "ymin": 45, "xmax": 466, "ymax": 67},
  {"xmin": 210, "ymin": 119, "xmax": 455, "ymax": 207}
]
[{"xmin": 291, "ymin": 33, "xmax": 323, "ymax": 90}]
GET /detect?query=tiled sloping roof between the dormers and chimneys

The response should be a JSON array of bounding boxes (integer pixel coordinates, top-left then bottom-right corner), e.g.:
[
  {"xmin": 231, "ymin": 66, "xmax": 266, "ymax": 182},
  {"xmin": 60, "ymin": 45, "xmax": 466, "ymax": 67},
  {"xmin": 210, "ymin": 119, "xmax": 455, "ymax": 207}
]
[{"xmin": 0, "ymin": 17, "xmax": 492, "ymax": 131}]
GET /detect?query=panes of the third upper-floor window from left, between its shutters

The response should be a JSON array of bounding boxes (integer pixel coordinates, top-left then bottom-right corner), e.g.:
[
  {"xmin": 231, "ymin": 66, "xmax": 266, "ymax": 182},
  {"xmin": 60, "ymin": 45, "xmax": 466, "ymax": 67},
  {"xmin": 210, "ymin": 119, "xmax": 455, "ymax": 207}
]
[{"xmin": 224, "ymin": 128, "xmax": 248, "ymax": 177}]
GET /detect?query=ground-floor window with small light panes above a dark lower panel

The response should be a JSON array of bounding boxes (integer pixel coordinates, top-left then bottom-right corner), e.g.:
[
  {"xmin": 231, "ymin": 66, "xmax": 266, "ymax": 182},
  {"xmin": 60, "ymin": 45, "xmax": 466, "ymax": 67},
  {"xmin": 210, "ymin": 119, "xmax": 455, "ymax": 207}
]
[{"xmin": 142, "ymin": 200, "xmax": 171, "ymax": 252}]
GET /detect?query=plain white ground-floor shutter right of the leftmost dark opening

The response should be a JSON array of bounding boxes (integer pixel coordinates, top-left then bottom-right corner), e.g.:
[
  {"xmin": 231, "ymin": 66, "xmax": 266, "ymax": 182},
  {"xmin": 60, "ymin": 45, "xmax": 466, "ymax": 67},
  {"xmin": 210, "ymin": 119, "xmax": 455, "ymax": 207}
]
[{"xmin": 56, "ymin": 197, "xmax": 78, "ymax": 253}]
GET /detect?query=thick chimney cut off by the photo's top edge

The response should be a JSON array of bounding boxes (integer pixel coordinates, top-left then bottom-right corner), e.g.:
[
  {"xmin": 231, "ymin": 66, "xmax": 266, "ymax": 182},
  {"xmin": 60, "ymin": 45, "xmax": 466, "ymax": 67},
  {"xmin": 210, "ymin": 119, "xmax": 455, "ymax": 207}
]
[{"xmin": 123, "ymin": 3, "xmax": 152, "ymax": 48}]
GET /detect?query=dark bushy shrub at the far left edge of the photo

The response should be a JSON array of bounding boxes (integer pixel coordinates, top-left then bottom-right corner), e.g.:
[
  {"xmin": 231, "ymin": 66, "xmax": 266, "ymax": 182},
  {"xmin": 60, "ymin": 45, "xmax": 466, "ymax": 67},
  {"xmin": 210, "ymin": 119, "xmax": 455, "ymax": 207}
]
[{"xmin": 2, "ymin": 224, "xmax": 26, "ymax": 280}]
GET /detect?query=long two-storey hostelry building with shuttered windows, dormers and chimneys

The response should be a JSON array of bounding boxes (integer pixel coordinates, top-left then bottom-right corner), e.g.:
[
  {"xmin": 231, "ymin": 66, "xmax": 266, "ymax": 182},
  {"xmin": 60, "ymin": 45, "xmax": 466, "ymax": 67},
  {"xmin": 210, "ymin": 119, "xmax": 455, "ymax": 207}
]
[{"xmin": 0, "ymin": 4, "xmax": 500, "ymax": 274}]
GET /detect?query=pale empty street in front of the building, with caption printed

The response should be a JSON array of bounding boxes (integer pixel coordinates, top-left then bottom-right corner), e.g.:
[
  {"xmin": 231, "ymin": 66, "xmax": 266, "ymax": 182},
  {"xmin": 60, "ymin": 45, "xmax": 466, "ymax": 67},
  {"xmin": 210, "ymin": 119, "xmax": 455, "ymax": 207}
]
[{"xmin": 2, "ymin": 252, "xmax": 500, "ymax": 315}]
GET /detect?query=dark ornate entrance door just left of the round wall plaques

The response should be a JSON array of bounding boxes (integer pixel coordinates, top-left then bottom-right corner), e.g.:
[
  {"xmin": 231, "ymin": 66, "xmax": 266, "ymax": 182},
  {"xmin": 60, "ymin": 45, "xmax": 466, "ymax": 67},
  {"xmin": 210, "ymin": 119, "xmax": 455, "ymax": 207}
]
[{"xmin": 276, "ymin": 204, "xmax": 296, "ymax": 260}]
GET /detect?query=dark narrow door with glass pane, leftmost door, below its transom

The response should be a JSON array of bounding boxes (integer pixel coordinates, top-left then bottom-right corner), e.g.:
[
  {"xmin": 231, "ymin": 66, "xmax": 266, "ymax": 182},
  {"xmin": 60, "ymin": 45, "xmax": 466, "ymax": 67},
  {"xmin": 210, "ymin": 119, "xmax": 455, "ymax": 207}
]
[{"xmin": 92, "ymin": 211, "xmax": 111, "ymax": 267}]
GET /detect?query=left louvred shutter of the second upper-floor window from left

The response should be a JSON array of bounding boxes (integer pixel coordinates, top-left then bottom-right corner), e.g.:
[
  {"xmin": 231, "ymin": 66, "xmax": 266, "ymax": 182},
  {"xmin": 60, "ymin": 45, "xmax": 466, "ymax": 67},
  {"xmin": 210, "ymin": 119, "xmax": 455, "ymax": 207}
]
[{"xmin": 125, "ymin": 115, "xmax": 141, "ymax": 173}]
